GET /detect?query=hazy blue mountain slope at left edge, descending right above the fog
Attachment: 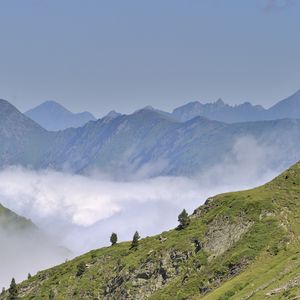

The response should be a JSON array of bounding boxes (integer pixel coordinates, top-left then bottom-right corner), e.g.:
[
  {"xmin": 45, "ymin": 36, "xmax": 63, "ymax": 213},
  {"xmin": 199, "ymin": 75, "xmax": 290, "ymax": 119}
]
[{"xmin": 0, "ymin": 100, "xmax": 51, "ymax": 167}]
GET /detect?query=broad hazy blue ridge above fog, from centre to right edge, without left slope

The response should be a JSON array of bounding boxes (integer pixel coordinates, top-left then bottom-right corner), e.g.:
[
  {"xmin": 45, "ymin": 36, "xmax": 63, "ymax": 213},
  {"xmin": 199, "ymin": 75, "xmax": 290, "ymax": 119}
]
[{"xmin": 44, "ymin": 109, "xmax": 300, "ymax": 178}]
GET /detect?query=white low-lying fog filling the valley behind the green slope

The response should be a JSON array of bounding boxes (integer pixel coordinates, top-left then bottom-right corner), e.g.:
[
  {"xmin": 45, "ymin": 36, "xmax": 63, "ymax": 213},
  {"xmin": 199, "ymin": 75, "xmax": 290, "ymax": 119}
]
[{"xmin": 0, "ymin": 138, "xmax": 292, "ymax": 286}]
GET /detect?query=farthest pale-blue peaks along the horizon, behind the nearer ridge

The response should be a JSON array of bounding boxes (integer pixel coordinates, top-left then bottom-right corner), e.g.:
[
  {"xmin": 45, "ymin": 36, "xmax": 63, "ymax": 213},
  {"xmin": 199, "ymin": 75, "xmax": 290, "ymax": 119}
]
[{"xmin": 25, "ymin": 90, "xmax": 300, "ymax": 131}]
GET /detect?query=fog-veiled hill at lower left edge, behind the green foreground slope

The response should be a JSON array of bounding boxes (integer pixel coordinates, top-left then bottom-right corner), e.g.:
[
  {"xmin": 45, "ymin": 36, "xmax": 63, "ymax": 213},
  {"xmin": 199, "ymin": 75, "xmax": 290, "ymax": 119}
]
[{"xmin": 0, "ymin": 204, "xmax": 71, "ymax": 288}]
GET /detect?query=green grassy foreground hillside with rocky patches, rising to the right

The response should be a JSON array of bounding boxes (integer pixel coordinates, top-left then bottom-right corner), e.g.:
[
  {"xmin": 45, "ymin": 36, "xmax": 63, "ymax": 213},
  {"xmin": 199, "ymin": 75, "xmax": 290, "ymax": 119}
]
[{"xmin": 6, "ymin": 163, "xmax": 300, "ymax": 300}]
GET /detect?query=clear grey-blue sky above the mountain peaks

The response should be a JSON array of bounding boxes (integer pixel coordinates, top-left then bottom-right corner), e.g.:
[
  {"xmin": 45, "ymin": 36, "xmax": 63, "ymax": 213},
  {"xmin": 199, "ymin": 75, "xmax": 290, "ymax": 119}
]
[{"xmin": 0, "ymin": 0, "xmax": 300, "ymax": 117}]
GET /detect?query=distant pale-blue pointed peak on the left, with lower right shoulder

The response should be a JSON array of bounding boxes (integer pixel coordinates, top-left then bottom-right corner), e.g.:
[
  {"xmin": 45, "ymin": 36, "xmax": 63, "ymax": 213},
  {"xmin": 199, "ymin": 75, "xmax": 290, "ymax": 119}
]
[{"xmin": 25, "ymin": 101, "xmax": 96, "ymax": 131}]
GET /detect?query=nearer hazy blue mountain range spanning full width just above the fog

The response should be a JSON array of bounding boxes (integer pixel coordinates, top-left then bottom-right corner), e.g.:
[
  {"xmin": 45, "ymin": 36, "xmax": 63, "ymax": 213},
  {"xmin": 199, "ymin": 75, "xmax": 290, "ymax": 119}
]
[{"xmin": 0, "ymin": 100, "xmax": 300, "ymax": 178}]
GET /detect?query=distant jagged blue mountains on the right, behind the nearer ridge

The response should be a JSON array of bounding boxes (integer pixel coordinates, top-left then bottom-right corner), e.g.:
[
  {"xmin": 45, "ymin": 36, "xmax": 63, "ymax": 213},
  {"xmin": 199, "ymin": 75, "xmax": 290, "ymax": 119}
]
[{"xmin": 172, "ymin": 91, "xmax": 300, "ymax": 123}]
